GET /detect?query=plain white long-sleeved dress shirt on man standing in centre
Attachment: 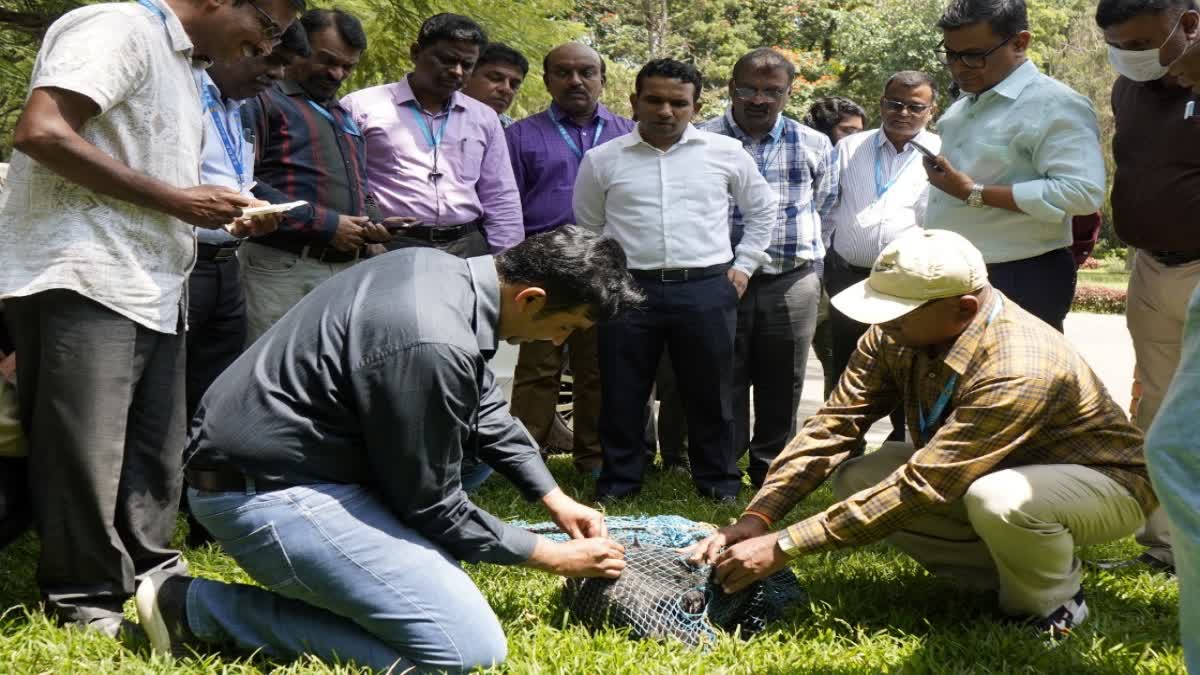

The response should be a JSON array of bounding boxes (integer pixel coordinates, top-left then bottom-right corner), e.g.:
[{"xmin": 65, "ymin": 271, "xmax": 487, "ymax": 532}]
[{"xmin": 574, "ymin": 125, "xmax": 779, "ymax": 275}]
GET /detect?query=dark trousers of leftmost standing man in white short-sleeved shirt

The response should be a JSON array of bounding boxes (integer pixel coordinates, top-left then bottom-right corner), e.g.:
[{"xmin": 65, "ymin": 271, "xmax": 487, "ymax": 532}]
[{"xmin": 5, "ymin": 291, "xmax": 186, "ymax": 621}]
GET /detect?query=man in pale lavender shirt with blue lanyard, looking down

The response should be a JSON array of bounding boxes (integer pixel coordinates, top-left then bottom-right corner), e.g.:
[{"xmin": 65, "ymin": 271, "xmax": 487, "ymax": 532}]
[{"xmin": 342, "ymin": 14, "xmax": 524, "ymax": 257}]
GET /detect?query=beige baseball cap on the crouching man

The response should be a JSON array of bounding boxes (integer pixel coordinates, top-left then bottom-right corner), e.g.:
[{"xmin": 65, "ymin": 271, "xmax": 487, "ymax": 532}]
[{"xmin": 830, "ymin": 229, "xmax": 988, "ymax": 323}]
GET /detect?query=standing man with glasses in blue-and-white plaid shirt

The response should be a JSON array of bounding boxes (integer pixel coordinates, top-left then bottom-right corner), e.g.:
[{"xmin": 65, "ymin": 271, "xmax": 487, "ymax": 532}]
[{"xmin": 700, "ymin": 48, "xmax": 838, "ymax": 488}]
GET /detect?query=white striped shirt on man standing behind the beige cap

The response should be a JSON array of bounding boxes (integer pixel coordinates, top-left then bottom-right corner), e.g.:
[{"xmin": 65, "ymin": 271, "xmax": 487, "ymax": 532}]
[{"xmin": 829, "ymin": 129, "xmax": 942, "ymax": 268}]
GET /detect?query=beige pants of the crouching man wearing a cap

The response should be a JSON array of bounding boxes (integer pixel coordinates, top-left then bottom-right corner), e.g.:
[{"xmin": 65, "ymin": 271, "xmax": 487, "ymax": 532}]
[{"xmin": 833, "ymin": 442, "xmax": 1145, "ymax": 616}]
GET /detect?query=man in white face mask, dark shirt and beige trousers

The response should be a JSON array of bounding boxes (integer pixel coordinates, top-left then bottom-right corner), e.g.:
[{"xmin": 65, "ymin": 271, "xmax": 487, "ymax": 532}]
[{"xmin": 1096, "ymin": 0, "xmax": 1200, "ymax": 578}]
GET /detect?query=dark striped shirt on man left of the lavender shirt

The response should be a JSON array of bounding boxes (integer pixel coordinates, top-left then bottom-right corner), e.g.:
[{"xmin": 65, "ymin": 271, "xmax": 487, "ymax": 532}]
[{"xmin": 241, "ymin": 80, "xmax": 367, "ymax": 247}]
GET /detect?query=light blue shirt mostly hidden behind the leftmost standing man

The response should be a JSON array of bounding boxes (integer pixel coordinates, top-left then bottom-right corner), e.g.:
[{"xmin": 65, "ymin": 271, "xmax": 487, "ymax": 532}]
[{"xmin": 196, "ymin": 68, "xmax": 254, "ymax": 244}]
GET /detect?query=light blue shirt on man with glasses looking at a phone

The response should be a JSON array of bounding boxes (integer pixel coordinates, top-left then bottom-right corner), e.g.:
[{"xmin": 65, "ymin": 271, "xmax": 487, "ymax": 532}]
[{"xmin": 925, "ymin": 61, "xmax": 1105, "ymax": 263}]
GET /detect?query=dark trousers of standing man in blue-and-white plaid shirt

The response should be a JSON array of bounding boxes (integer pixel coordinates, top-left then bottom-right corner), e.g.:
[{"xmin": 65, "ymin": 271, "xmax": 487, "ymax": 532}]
[{"xmin": 733, "ymin": 264, "xmax": 821, "ymax": 485}]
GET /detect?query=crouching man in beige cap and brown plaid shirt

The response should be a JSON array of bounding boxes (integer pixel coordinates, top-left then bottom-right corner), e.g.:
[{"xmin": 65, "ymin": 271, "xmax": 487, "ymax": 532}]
[{"xmin": 691, "ymin": 229, "xmax": 1156, "ymax": 637}]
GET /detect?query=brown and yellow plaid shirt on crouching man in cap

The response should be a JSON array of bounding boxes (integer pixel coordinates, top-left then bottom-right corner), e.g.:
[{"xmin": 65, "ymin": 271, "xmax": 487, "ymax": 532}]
[{"xmin": 746, "ymin": 289, "xmax": 1157, "ymax": 552}]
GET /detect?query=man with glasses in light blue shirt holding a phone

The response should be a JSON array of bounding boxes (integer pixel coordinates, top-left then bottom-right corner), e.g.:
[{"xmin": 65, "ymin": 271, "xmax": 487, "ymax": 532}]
[{"xmin": 924, "ymin": 0, "xmax": 1105, "ymax": 330}]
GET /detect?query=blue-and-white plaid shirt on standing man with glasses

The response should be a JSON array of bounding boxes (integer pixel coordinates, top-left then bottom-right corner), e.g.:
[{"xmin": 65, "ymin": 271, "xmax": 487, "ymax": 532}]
[{"xmin": 698, "ymin": 109, "xmax": 838, "ymax": 274}]
